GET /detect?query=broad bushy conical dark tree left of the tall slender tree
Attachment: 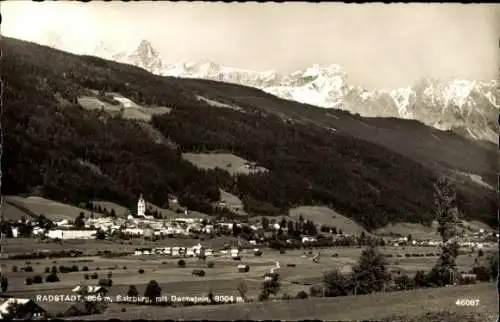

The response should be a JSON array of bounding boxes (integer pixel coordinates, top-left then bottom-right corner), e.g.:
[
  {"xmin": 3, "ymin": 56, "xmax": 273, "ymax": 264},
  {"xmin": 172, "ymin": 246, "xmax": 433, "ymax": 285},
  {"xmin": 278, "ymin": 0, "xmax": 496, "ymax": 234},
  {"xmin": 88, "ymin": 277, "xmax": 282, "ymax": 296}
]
[{"xmin": 353, "ymin": 243, "xmax": 391, "ymax": 294}]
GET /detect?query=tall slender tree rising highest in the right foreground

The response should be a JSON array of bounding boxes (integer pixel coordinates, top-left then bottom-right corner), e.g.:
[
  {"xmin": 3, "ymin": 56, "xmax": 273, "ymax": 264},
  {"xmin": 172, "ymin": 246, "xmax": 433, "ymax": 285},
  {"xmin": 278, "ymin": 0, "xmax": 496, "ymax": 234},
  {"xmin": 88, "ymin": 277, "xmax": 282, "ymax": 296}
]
[{"xmin": 428, "ymin": 177, "xmax": 459, "ymax": 286}]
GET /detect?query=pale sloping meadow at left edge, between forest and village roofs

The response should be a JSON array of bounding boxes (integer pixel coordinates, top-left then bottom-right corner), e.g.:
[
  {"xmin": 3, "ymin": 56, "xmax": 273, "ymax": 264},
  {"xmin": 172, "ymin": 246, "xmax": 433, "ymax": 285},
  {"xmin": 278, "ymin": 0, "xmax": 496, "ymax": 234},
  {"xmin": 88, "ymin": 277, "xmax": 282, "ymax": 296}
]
[{"xmin": 2, "ymin": 196, "xmax": 106, "ymax": 221}]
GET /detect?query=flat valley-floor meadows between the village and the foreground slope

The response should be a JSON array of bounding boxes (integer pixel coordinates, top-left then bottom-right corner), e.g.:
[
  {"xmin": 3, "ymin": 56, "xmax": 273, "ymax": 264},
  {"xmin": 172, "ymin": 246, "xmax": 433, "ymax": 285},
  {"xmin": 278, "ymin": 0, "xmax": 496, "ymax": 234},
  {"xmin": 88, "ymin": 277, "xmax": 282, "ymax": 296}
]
[{"xmin": 2, "ymin": 243, "xmax": 492, "ymax": 319}]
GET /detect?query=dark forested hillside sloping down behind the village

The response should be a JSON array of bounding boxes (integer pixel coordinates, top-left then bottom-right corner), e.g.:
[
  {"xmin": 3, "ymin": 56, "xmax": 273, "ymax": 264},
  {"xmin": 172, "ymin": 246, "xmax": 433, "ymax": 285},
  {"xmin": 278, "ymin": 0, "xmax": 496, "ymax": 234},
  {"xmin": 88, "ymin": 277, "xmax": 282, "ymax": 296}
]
[{"xmin": 1, "ymin": 37, "xmax": 496, "ymax": 229}]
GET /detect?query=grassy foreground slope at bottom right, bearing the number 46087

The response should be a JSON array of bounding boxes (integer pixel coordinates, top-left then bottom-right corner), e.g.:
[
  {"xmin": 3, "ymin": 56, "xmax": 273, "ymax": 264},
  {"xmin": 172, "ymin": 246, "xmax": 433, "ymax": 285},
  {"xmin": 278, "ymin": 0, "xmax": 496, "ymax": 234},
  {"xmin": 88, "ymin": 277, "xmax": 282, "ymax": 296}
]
[{"xmin": 65, "ymin": 283, "xmax": 498, "ymax": 322}]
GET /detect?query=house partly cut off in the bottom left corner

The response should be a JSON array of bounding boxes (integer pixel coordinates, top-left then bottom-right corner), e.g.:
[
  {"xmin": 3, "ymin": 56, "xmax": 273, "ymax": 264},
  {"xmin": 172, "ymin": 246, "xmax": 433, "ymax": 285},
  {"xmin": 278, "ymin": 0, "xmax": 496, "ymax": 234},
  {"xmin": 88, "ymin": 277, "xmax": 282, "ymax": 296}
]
[{"xmin": 0, "ymin": 298, "xmax": 47, "ymax": 320}]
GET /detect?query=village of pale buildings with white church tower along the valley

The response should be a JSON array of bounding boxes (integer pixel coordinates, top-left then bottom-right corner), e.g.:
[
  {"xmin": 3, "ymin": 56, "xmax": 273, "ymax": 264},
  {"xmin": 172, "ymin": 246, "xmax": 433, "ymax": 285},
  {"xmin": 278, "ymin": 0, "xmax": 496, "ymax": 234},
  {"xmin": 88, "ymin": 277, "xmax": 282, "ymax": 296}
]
[{"xmin": 1, "ymin": 195, "xmax": 499, "ymax": 257}]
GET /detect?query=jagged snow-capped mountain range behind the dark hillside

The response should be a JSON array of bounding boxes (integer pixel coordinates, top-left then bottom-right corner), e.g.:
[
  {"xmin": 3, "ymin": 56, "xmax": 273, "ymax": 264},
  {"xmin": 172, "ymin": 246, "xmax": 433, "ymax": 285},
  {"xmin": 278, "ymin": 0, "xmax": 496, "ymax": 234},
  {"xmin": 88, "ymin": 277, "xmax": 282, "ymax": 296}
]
[{"xmin": 55, "ymin": 40, "xmax": 500, "ymax": 143}]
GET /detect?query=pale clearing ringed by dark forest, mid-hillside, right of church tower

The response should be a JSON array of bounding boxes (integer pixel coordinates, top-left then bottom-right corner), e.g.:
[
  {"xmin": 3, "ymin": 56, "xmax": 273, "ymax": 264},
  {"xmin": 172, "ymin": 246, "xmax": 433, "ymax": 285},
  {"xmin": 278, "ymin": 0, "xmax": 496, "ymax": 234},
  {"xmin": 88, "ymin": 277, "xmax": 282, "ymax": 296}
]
[{"xmin": 182, "ymin": 153, "xmax": 267, "ymax": 175}]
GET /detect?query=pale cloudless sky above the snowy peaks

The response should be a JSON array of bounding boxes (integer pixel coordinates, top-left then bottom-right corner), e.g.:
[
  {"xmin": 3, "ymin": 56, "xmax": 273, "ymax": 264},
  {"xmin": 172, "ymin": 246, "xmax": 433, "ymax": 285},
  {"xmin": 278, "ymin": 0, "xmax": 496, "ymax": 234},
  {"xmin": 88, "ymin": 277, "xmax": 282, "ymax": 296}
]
[{"xmin": 0, "ymin": 0, "xmax": 500, "ymax": 89}]
